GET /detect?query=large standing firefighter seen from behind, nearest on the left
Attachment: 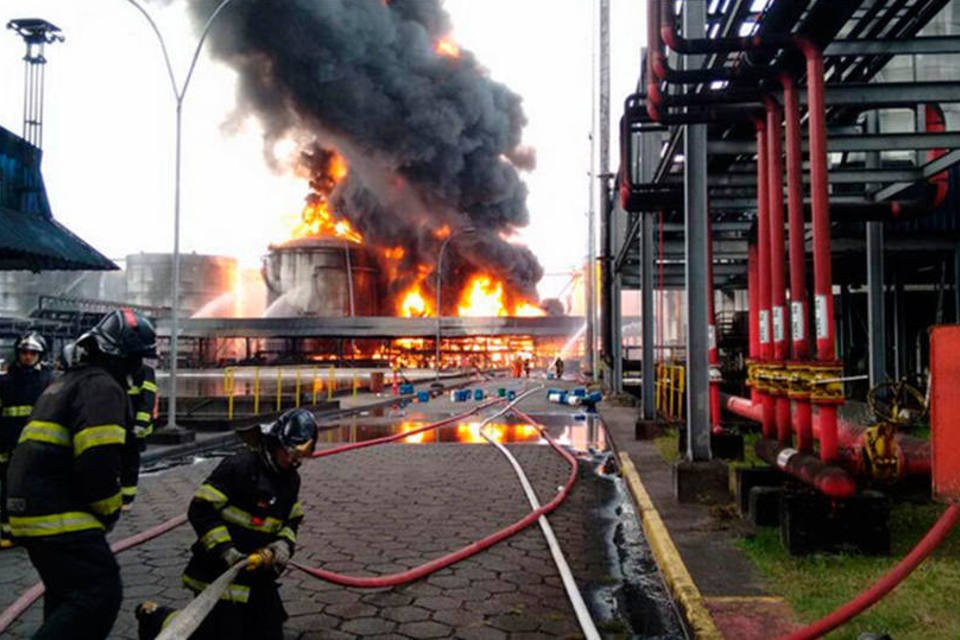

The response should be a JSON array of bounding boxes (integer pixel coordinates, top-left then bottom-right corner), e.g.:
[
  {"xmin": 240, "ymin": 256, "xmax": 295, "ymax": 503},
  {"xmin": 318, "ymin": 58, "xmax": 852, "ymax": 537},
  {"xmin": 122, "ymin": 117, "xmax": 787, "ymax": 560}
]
[{"xmin": 7, "ymin": 308, "xmax": 156, "ymax": 640}]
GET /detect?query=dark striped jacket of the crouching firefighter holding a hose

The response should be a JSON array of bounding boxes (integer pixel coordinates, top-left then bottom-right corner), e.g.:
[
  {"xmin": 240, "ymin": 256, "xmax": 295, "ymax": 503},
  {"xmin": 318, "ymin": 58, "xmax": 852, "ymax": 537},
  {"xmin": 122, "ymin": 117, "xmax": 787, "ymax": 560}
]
[{"xmin": 183, "ymin": 451, "xmax": 303, "ymax": 603}]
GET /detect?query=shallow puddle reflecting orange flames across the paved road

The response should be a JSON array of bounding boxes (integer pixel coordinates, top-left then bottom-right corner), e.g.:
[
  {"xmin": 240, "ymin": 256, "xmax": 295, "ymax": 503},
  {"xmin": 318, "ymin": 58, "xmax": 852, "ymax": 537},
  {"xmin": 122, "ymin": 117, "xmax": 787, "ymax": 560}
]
[{"xmin": 320, "ymin": 416, "xmax": 607, "ymax": 451}]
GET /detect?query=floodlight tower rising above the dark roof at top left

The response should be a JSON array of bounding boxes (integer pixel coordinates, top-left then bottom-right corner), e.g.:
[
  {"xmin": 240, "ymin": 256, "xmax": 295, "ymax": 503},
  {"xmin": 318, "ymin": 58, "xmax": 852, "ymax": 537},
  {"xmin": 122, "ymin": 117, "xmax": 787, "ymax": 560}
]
[{"xmin": 7, "ymin": 18, "xmax": 64, "ymax": 149}]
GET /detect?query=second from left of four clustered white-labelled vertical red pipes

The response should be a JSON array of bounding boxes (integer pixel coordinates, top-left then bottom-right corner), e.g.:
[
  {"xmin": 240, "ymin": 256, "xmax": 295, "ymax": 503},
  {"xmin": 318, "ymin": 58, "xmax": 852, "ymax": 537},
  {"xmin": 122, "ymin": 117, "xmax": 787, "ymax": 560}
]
[{"xmin": 764, "ymin": 98, "xmax": 791, "ymax": 445}]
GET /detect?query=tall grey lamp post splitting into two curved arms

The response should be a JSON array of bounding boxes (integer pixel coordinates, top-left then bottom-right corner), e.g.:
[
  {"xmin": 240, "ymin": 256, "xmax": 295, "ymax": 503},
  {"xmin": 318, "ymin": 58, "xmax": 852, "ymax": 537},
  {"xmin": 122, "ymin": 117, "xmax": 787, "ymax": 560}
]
[{"xmin": 127, "ymin": 0, "xmax": 233, "ymax": 440}]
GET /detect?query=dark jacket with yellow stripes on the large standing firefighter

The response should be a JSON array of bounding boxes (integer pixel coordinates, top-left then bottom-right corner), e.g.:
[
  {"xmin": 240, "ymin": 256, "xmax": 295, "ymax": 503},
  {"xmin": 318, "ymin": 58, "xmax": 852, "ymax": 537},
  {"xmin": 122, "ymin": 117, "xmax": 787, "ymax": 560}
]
[{"xmin": 7, "ymin": 365, "xmax": 132, "ymax": 538}]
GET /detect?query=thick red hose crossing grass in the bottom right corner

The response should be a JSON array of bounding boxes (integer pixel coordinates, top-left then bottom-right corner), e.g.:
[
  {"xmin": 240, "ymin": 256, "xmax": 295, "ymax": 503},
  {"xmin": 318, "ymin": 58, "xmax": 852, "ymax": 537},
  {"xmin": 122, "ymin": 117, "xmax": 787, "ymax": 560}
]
[{"xmin": 781, "ymin": 505, "xmax": 960, "ymax": 640}]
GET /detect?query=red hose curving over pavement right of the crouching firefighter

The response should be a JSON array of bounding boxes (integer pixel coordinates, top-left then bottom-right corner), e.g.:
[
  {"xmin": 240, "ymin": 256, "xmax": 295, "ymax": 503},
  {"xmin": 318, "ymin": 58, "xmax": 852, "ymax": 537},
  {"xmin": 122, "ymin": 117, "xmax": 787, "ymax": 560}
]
[{"xmin": 291, "ymin": 409, "xmax": 578, "ymax": 589}]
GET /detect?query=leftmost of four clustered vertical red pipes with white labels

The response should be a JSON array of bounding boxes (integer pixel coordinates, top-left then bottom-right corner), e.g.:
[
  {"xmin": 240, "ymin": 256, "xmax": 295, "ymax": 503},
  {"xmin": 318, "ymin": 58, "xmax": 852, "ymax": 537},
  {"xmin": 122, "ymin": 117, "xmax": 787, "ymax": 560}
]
[{"xmin": 755, "ymin": 118, "xmax": 775, "ymax": 438}]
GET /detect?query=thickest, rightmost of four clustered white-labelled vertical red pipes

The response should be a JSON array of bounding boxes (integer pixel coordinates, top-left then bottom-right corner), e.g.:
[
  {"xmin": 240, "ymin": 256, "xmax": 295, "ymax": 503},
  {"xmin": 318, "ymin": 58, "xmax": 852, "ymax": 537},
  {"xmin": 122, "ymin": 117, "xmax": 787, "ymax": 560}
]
[{"xmin": 797, "ymin": 38, "xmax": 838, "ymax": 463}]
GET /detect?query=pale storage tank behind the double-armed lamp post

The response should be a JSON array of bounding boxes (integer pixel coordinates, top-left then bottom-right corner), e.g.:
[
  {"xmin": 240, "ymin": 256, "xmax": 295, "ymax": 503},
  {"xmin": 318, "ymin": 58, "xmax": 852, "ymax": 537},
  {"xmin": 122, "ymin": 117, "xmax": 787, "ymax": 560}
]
[{"xmin": 126, "ymin": 253, "xmax": 237, "ymax": 317}]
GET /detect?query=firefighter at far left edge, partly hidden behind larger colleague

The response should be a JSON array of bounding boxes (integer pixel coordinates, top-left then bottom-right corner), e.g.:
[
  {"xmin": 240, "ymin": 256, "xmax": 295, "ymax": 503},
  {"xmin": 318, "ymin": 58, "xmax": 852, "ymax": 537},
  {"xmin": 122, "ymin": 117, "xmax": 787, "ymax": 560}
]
[{"xmin": 0, "ymin": 333, "xmax": 53, "ymax": 549}]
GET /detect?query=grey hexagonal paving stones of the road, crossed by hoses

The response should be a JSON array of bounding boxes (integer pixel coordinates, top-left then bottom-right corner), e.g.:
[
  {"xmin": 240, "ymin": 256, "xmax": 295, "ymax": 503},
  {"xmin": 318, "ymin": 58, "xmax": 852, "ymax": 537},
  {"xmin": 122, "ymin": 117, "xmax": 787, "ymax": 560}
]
[{"xmin": 0, "ymin": 382, "xmax": 679, "ymax": 640}]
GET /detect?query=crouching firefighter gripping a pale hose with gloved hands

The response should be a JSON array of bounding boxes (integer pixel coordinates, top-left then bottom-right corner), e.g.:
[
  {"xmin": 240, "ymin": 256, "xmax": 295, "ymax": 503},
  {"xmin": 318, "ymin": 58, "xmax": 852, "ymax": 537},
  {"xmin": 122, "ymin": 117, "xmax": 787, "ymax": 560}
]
[{"xmin": 136, "ymin": 409, "xmax": 317, "ymax": 640}]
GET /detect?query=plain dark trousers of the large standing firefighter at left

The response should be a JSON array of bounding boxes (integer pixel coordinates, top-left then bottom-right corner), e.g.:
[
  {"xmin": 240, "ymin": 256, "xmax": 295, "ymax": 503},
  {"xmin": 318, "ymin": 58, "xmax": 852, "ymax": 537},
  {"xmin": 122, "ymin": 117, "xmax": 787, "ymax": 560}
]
[{"xmin": 22, "ymin": 531, "xmax": 123, "ymax": 640}]
